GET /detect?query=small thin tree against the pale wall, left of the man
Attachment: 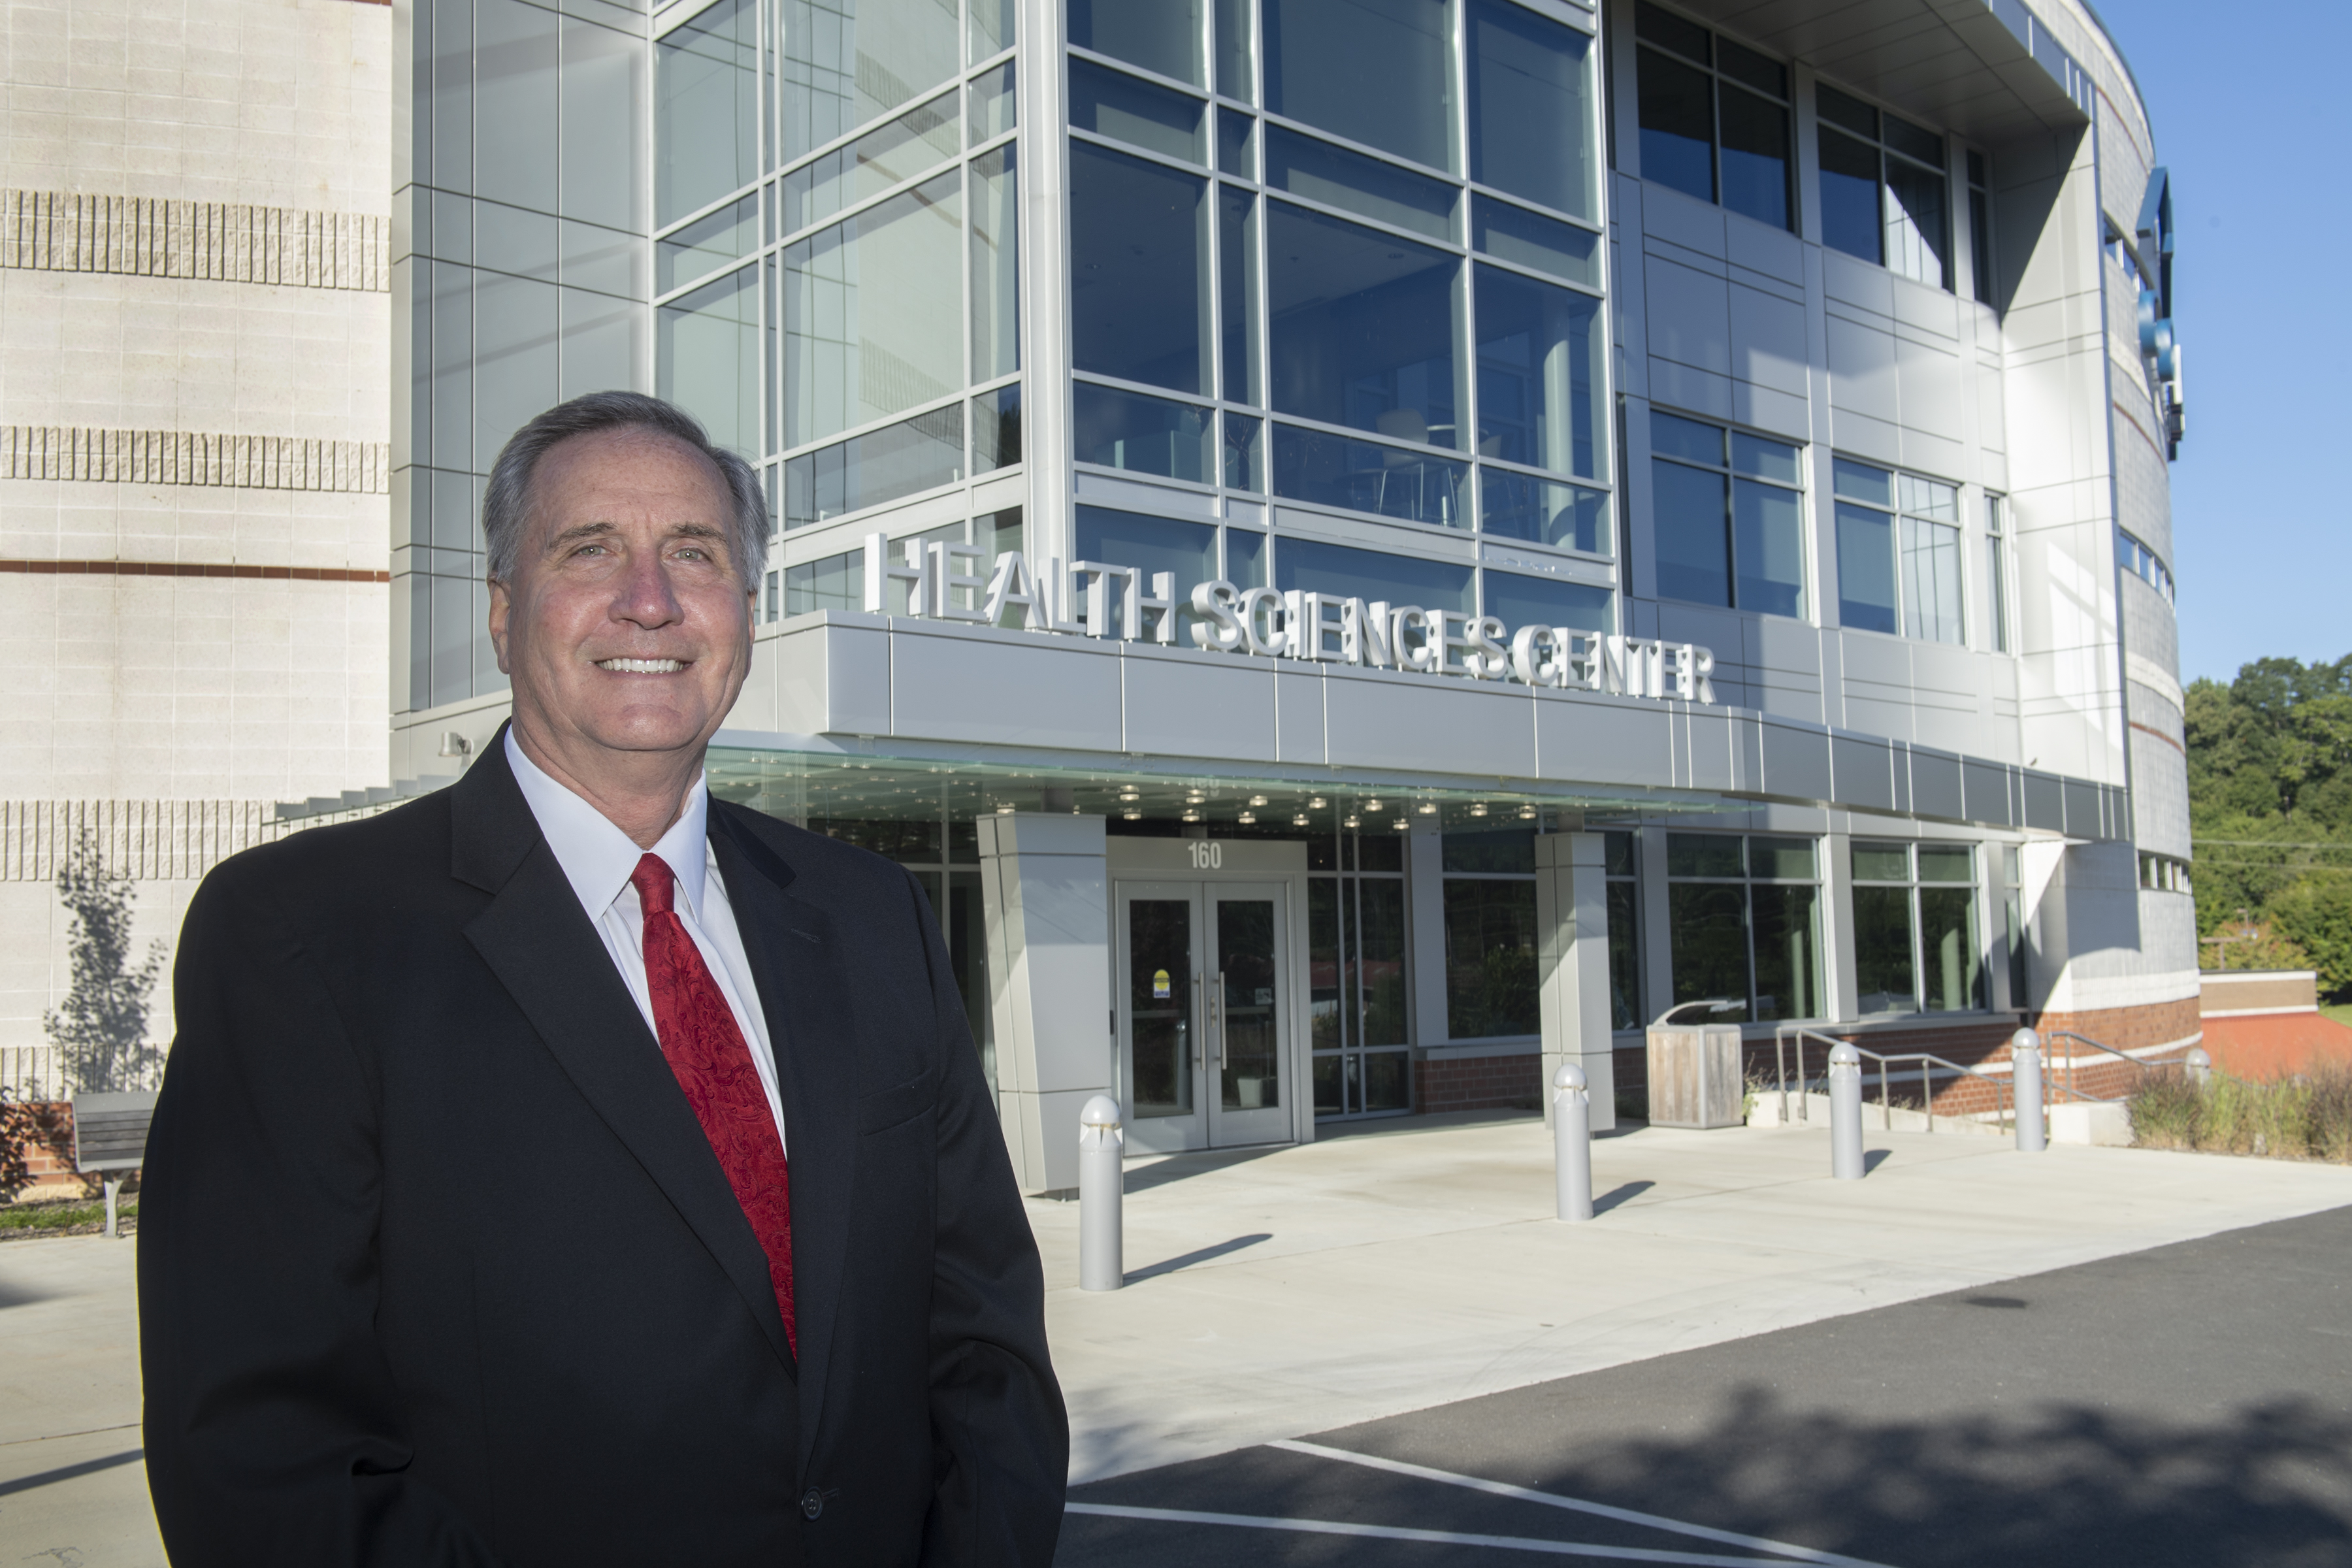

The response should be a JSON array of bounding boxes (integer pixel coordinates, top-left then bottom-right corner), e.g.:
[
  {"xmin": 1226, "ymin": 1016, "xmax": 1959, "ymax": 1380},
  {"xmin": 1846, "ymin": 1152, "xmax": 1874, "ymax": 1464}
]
[{"xmin": 40, "ymin": 828, "xmax": 165, "ymax": 1093}]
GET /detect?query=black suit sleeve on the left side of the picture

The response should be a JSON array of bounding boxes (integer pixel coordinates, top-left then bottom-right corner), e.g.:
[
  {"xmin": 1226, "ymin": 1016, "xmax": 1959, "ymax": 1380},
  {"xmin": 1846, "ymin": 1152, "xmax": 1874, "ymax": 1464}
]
[{"xmin": 139, "ymin": 858, "xmax": 497, "ymax": 1568}]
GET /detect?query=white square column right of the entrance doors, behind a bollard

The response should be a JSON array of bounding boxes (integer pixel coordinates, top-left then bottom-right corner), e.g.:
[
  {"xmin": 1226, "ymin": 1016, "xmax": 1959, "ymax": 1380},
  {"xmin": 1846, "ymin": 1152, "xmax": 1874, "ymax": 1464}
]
[{"xmin": 1536, "ymin": 832, "xmax": 1616, "ymax": 1133}]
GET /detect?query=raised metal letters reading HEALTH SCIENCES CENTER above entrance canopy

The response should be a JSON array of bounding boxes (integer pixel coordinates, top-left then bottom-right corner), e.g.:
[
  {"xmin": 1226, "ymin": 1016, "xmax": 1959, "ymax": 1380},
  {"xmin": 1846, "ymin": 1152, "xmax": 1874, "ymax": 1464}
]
[{"xmin": 866, "ymin": 534, "xmax": 1714, "ymax": 703}]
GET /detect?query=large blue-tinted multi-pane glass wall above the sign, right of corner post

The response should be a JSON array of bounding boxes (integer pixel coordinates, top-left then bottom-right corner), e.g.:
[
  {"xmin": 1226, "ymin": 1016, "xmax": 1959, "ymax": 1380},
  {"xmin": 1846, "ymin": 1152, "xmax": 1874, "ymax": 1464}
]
[{"xmin": 1066, "ymin": 0, "xmax": 1616, "ymax": 625}]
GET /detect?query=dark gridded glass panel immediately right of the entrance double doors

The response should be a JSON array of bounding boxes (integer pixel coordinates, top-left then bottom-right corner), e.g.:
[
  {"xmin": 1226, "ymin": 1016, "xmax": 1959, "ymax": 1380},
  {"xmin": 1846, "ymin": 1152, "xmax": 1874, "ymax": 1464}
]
[{"xmin": 1308, "ymin": 832, "xmax": 1414, "ymax": 1117}]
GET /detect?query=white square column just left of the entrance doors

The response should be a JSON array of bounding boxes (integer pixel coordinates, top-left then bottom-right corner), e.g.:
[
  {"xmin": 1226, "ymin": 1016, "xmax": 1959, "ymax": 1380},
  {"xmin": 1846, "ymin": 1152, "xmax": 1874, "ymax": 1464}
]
[{"xmin": 979, "ymin": 813, "xmax": 1113, "ymax": 1192}]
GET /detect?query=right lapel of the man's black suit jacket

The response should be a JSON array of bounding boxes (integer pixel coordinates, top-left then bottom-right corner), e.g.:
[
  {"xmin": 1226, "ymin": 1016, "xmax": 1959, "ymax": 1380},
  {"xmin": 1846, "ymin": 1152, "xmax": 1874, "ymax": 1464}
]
[{"xmin": 710, "ymin": 799, "xmax": 858, "ymax": 1476}]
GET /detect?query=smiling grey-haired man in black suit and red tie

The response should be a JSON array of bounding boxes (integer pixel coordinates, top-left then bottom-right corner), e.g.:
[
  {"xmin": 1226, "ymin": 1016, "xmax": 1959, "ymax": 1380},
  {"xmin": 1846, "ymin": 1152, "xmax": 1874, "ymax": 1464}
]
[{"xmin": 139, "ymin": 393, "xmax": 1068, "ymax": 1568}]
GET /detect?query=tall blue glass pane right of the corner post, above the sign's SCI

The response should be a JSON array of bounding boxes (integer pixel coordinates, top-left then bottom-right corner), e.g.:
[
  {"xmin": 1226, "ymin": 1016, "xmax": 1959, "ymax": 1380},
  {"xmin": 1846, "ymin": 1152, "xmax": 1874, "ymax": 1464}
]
[{"xmin": 1070, "ymin": 141, "xmax": 1209, "ymax": 393}]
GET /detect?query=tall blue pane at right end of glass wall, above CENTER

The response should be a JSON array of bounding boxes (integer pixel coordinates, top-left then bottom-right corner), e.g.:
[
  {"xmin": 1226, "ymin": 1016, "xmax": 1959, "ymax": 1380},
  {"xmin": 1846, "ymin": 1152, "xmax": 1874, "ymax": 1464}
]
[{"xmin": 1477, "ymin": 266, "xmax": 1609, "ymax": 480}]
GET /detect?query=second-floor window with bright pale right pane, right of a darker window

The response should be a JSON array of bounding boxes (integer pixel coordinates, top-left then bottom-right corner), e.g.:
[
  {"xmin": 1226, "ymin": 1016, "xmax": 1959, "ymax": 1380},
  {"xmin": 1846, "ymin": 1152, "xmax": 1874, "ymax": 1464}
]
[{"xmin": 1832, "ymin": 459, "xmax": 1968, "ymax": 644}]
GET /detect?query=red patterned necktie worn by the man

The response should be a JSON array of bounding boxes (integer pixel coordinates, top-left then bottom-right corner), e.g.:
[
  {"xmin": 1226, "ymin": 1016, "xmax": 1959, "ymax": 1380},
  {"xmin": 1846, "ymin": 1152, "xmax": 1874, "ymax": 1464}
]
[{"xmin": 630, "ymin": 856, "xmax": 800, "ymax": 1354}]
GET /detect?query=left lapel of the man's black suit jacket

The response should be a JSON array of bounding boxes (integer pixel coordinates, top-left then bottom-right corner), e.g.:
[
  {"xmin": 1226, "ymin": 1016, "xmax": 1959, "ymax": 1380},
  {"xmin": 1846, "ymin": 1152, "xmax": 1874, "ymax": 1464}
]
[{"xmin": 449, "ymin": 731, "xmax": 800, "ymax": 1371}]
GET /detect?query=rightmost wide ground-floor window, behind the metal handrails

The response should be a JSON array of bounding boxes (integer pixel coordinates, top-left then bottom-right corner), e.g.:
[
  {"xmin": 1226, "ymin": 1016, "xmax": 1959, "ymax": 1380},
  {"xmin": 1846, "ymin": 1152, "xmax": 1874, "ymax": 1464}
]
[{"xmin": 1854, "ymin": 840, "xmax": 1985, "ymax": 1013}]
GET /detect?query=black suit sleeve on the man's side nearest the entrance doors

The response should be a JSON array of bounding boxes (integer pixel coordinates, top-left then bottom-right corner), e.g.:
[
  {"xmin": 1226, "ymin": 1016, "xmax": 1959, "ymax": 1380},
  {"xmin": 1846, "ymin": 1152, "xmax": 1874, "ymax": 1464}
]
[{"xmin": 908, "ymin": 877, "xmax": 1070, "ymax": 1568}]
